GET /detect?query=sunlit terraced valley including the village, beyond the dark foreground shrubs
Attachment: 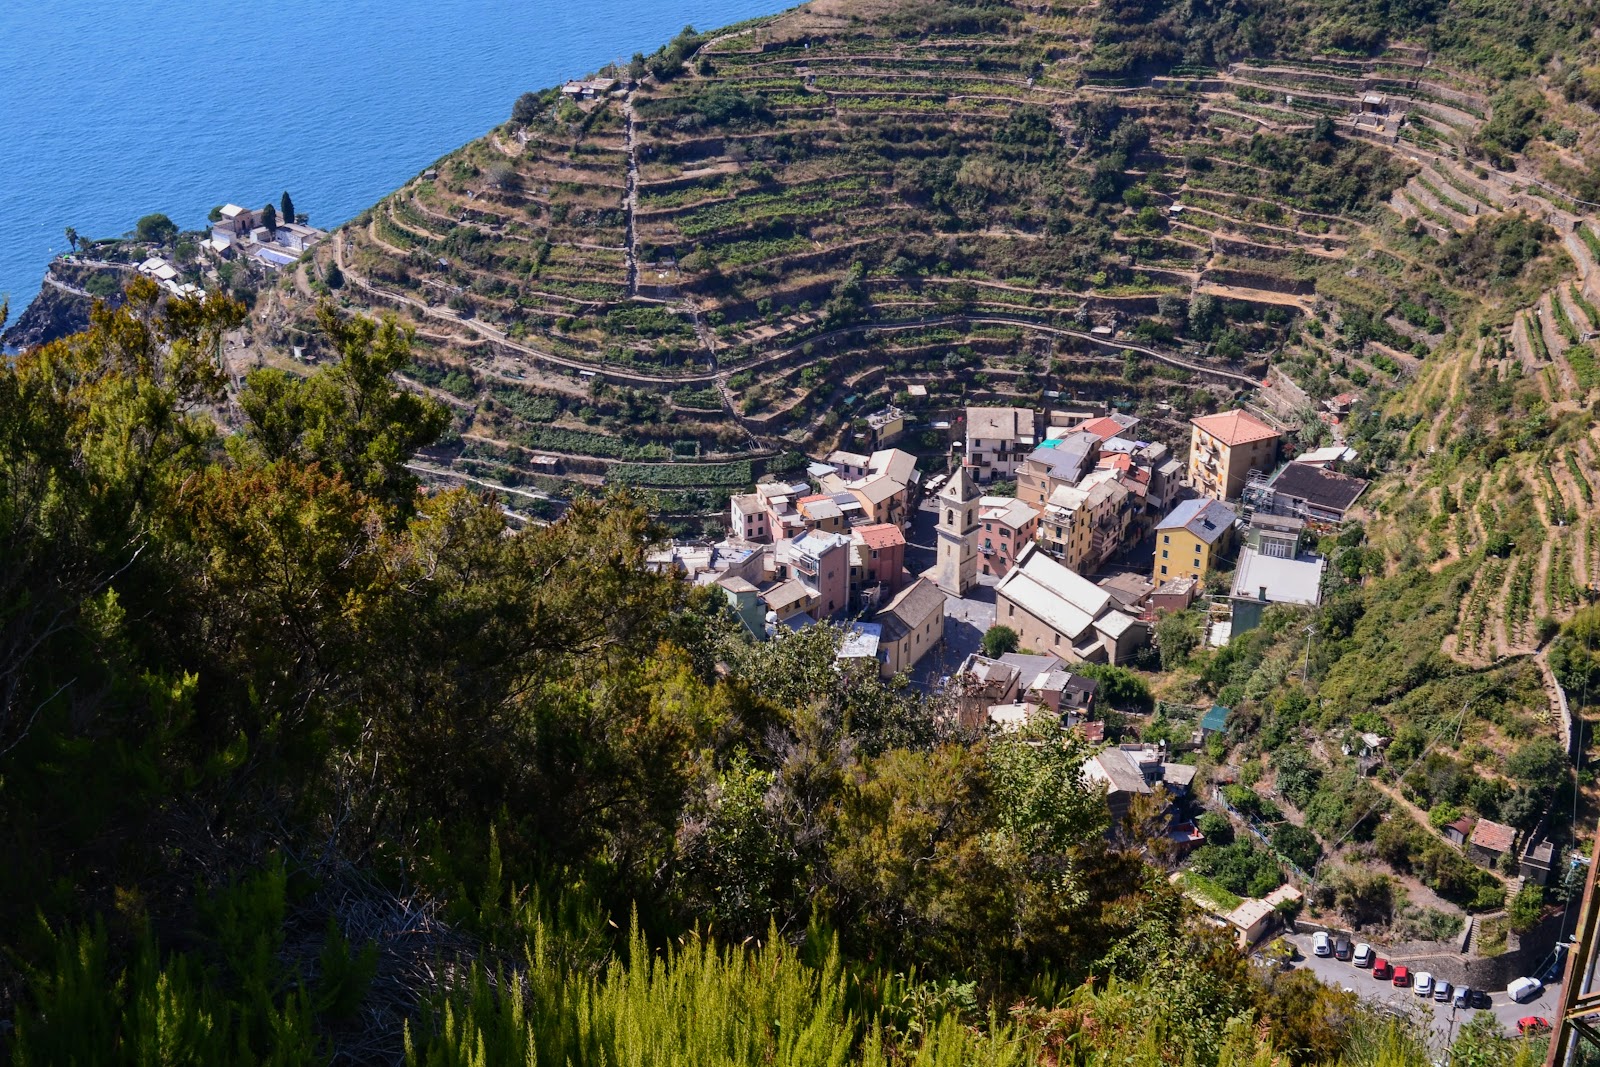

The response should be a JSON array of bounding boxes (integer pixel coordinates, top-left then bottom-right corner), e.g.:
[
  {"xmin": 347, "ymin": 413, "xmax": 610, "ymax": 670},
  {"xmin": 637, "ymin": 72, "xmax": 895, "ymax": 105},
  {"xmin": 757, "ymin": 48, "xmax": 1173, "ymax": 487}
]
[{"xmin": 15, "ymin": 0, "xmax": 1600, "ymax": 1049}]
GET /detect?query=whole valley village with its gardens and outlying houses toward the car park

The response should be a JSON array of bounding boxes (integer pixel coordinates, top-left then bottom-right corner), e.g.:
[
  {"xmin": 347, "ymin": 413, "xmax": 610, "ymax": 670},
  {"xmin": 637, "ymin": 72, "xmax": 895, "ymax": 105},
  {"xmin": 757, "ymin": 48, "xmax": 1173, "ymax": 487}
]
[{"xmin": 640, "ymin": 400, "xmax": 1587, "ymax": 987}]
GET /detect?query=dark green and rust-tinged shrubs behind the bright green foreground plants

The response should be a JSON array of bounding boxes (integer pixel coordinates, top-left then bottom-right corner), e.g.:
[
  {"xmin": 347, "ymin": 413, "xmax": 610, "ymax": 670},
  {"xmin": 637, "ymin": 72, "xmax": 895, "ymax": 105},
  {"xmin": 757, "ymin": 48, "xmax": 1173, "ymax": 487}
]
[{"xmin": 0, "ymin": 289, "xmax": 1273, "ymax": 1062}]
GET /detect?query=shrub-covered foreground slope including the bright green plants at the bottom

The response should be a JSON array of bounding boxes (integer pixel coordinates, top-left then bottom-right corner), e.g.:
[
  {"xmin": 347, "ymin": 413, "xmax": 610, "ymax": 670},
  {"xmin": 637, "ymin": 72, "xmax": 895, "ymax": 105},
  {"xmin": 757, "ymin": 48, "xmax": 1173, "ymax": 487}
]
[{"xmin": 0, "ymin": 278, "xmax": 1465, "ymax": 1067}]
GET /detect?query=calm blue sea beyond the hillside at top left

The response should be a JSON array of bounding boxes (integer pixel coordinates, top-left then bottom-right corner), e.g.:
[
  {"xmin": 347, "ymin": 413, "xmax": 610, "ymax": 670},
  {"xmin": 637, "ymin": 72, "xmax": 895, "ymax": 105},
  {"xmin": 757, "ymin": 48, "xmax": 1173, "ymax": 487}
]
[{"xmin": 0, "ymin": 0, "xmax": 794, "ymax": 308}]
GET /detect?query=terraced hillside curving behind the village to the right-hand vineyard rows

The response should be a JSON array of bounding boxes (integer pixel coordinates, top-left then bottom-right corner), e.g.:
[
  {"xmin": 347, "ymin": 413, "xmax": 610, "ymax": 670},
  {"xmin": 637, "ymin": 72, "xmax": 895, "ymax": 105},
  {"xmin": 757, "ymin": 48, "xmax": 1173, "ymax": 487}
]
[{"xmin": 267, "ymin": 0, "xmax": 1600, "ymax": 633}]
